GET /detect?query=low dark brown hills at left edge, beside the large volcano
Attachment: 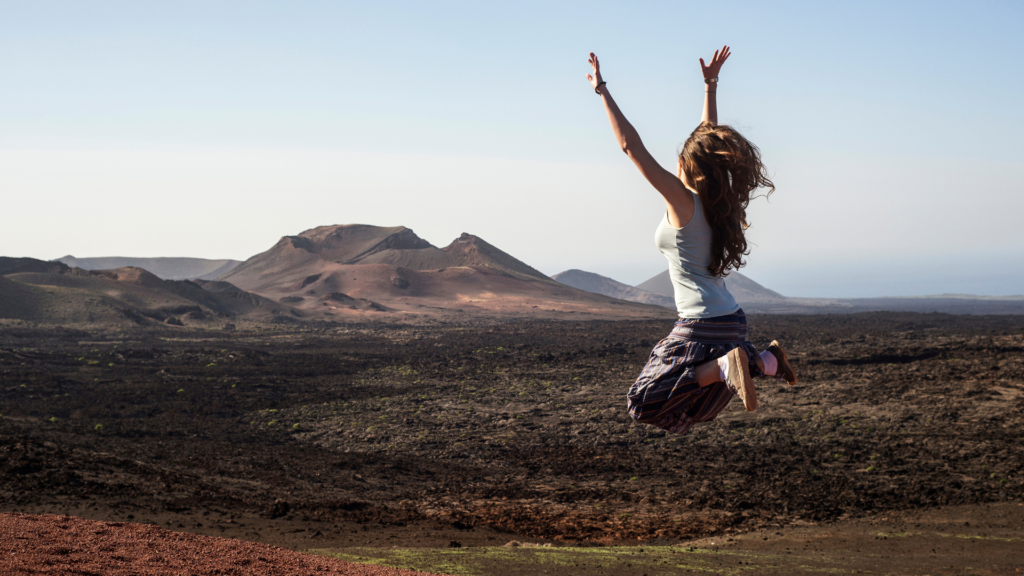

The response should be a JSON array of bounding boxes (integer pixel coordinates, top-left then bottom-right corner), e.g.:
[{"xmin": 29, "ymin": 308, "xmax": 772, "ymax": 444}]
[{"xmin": 0, "ymin": 258, "xmax": 302, "ymax": 324}]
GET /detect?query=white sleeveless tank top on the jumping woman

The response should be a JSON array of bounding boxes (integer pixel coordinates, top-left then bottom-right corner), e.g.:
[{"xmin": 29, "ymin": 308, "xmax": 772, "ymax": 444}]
[{"xmin": 654, "ymin": 194, "xmax": 739, "ymax": 318}]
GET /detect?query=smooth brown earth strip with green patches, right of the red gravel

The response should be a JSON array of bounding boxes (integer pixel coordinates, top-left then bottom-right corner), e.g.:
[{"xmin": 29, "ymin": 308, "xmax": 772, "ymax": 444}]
[{"xmin": 314, "ymin": 504, "xmax": 1024, "ymax": 576}]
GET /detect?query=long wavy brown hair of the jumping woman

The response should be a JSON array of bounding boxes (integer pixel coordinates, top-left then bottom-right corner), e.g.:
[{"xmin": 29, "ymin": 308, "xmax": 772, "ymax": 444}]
[{"xmin": 679, "ymin": 122, "xmax": 775, "ymax": 276}]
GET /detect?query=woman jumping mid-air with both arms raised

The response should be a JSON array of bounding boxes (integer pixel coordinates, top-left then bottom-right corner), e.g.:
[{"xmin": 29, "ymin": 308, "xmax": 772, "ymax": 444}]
[{"xmin": 587, "ymin": 46, "xmax": 797, "ymax": 434}]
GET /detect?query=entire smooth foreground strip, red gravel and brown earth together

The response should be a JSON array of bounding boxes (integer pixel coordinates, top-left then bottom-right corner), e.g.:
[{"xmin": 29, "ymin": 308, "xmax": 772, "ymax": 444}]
[{"xmin": 6, "ymin": 503, "xmax": 1024, "ymax": 576}]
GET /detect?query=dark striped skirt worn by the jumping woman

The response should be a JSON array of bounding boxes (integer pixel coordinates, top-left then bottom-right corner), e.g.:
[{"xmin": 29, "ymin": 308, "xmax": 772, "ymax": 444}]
[{"xmin": 627, "ymin": 310, "xmax": 764, "ymax": 434}]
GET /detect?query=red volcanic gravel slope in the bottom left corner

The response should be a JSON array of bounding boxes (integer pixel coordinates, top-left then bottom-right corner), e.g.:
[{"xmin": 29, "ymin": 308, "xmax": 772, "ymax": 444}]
[{"xmin": 0, "ymin": 513, "xmax": 444, "ymax": 576}]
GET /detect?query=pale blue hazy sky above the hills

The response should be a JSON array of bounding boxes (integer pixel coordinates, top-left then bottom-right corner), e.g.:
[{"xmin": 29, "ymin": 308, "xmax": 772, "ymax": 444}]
[{"xmin": 0, "ymin": 0, "xmax": 1024, "ymax": 296}]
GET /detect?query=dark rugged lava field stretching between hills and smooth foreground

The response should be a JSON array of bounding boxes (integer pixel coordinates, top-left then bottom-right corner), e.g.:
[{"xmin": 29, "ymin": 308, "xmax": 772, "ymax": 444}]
[{"xmin": 0, "ymin": 313, "xmax": 1024, "ymax": 573}]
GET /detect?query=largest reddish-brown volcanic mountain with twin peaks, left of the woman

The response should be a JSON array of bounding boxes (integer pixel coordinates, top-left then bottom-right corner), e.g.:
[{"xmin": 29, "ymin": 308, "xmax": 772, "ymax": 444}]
[{"xmin": 218, "ymin": 224, "xmax": 664, "ymax": 318}]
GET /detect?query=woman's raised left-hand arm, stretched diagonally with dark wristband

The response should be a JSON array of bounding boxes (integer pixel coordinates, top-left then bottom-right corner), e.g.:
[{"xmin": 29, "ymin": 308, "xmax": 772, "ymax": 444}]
[{"xmin": 587, "ymin": 52, "xmax": 693, "ymax": 213}]
